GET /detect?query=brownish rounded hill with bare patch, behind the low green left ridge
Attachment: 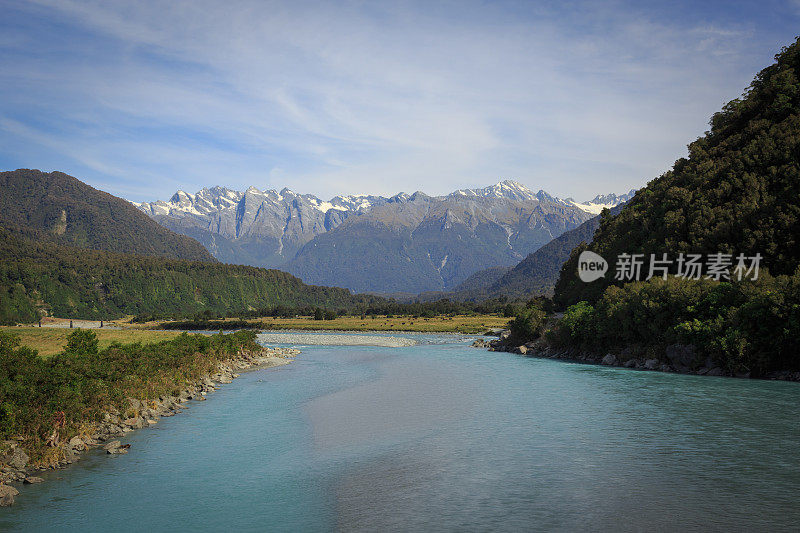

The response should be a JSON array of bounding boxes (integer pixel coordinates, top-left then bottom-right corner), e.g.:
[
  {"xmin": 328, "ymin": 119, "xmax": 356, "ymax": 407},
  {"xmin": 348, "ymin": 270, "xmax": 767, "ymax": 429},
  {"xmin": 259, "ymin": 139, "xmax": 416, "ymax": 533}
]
[{"xmin": 0, "ymin": 169, "xmax": 215, "ymax": 262}]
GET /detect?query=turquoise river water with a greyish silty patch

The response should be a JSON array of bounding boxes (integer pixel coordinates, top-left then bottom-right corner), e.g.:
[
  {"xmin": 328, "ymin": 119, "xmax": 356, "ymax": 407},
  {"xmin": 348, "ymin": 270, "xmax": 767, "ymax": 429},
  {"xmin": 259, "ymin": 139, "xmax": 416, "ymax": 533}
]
[{"xmin": 0, "ymin": 335, "xmax": 800, "ymax": 533}]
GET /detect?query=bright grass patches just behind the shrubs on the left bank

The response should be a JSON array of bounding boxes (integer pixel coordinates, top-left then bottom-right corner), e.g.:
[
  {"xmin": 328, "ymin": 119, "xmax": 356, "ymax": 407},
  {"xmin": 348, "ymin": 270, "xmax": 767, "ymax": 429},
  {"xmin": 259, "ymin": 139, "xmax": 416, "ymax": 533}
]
[{"xmin": 0, "ymin": 327, "xmax": 181, "ymax": 356}]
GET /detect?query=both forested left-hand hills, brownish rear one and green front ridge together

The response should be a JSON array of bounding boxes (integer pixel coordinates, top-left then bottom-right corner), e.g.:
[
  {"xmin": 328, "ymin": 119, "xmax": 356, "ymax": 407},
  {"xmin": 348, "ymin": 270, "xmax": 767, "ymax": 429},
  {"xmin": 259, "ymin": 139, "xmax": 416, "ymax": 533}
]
[{"xmin": 0, "ymin": 169, "xmax": 386, "ymax": 325}]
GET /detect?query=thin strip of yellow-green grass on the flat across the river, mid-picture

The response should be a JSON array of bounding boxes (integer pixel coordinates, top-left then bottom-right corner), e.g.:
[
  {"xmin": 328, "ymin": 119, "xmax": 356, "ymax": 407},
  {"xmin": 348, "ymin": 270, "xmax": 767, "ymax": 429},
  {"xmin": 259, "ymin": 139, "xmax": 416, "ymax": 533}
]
[{"xmin": 137, "ymin": 315, "xmax": 509, "ymax": 334}]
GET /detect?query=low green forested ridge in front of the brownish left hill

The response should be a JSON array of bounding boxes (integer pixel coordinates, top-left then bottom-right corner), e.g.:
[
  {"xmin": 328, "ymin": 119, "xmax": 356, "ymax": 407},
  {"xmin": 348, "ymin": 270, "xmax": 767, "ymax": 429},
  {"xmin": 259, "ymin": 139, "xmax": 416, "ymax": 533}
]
[{"xmin": 0, "ymin": 226, "xmax": 380, "ymax": 324}]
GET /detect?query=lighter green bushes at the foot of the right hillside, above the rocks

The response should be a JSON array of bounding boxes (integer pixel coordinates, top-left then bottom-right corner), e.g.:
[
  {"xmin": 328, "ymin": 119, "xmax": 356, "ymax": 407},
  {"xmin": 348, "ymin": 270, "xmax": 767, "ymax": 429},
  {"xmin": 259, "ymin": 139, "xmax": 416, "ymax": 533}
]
[{"xmin": 548, "ymin": 271, "xmax": 800, "ymax": 376}]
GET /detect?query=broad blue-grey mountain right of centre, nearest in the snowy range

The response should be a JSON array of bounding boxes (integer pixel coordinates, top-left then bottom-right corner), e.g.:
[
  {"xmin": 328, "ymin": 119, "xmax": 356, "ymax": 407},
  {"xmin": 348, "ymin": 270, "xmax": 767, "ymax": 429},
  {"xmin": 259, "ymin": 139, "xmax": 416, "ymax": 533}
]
[{"xmin": 287, "ymin": 181, "xmax": 591, "ymax": 293}]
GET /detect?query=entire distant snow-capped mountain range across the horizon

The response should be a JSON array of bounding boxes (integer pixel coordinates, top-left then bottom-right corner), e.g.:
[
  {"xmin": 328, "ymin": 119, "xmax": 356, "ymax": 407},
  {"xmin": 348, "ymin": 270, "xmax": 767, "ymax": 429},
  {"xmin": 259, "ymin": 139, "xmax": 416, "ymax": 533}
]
[{"xmin": 135, "ymin": 181, "xmax": 633, "ymax": 293}]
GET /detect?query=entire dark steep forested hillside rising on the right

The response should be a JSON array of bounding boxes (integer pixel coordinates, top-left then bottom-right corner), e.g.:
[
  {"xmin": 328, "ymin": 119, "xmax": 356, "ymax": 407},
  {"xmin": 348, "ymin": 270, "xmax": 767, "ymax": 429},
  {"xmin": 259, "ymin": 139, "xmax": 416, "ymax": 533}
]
[{"xmin": 532, "ymin": 41, "xmax": 800, "ymax": 376}]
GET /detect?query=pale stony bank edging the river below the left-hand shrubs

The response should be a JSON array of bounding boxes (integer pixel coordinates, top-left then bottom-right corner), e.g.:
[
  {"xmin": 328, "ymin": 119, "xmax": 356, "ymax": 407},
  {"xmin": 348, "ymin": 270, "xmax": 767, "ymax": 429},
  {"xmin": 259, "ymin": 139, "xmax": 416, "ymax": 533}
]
[{"xmin": 0, "ymin": 347, "xmax": 300, "ymax": 507}]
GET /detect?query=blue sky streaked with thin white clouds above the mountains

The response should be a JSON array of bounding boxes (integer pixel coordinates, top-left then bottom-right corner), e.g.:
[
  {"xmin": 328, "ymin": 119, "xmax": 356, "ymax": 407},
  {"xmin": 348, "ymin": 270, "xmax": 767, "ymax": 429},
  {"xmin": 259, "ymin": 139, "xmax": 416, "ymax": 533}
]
[{"xmin": 0, "ymin": 0, "xmax": 800, "ymax": 200}]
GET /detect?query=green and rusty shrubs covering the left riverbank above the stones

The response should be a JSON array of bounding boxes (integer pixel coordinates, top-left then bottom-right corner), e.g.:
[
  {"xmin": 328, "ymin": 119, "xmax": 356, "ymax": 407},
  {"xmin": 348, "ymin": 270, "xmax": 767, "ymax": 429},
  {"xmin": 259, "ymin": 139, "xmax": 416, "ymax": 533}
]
[{"xmin": 0, "ymin": 329, "xmax": 259, "ymax": 463}]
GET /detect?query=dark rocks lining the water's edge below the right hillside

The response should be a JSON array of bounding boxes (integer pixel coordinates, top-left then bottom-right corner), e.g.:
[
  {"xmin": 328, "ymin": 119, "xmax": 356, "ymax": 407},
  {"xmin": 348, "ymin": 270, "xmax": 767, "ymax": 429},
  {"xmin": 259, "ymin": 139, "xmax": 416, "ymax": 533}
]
[{"xmin": 472, "ymin": 330, "xmax": 800, "ymax": 381}]
